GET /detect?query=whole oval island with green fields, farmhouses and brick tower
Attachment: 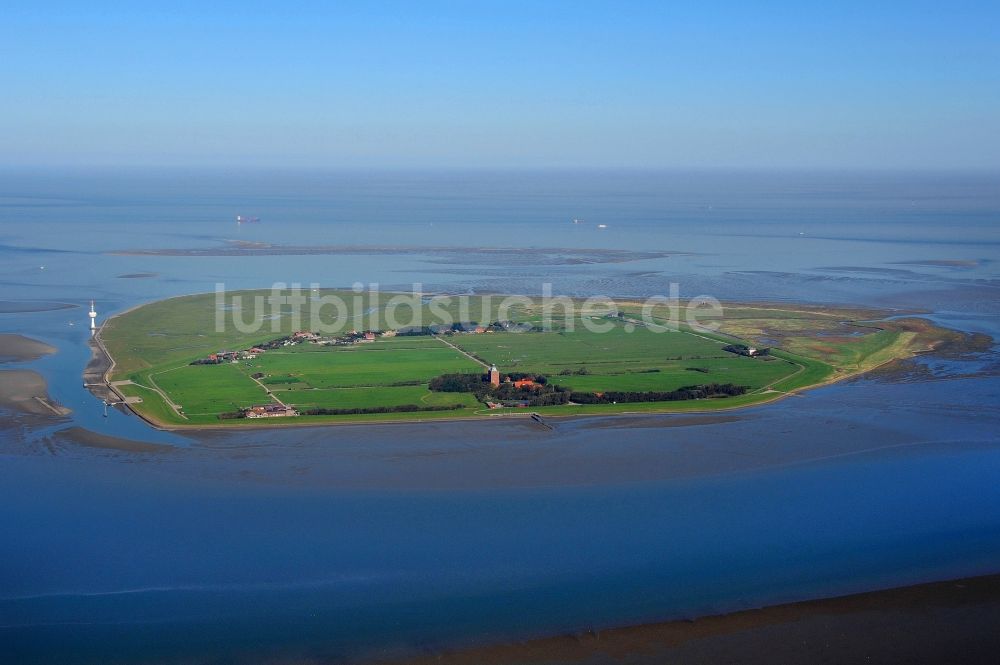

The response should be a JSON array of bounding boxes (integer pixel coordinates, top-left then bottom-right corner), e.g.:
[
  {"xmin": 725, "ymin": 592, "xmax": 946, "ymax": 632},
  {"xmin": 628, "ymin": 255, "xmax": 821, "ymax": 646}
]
[{"xmin": 91, "ymin": 289, "xmax": 961, "ymax": 429}]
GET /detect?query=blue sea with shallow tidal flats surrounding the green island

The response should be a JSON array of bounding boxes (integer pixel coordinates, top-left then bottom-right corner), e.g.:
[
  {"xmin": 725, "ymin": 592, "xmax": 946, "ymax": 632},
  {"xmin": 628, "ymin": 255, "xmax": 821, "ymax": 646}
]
[{"xmin": 0, "ymin": 169, "xmax": 1000, "ymax": 664}]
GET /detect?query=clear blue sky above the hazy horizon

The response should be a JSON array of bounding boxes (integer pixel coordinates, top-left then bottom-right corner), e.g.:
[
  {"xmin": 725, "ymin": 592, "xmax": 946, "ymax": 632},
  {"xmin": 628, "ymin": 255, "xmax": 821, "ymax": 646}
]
[{"xmin": 0, "ymin": 0, "xmax": 1000, "ymax": 170}]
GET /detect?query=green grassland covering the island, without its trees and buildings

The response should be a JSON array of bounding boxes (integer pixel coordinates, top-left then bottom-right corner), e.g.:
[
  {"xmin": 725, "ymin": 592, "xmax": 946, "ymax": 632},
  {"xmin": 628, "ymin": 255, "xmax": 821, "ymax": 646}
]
[{"xmin": 100, "ymin": 292, "xmax": 929, "ymax": 426}]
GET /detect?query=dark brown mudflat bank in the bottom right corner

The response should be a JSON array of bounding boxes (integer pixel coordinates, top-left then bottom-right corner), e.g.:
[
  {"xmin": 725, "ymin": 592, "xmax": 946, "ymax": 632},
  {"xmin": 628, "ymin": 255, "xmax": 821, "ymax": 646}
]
[{"xmin": 366, "ymin": 573, "xmax": 1000, "ymax": 665}]
